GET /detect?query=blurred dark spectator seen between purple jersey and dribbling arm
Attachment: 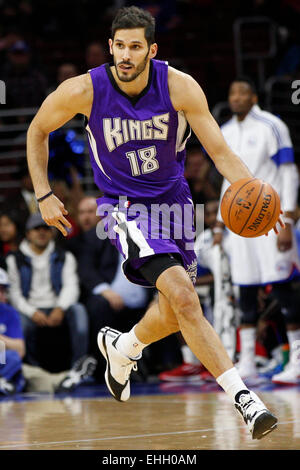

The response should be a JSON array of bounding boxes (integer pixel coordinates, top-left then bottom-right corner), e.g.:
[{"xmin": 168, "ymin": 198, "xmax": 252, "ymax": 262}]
[{"xmin": 184, "ymin": 145, "xmax": 219, "ymax": 204}]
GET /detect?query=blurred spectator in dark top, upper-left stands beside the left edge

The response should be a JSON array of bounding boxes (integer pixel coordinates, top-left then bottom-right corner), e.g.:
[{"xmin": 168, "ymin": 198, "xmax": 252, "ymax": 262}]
[{"xmin": 1, "ymin": 40, "xmax": 47, "ymax": 111}]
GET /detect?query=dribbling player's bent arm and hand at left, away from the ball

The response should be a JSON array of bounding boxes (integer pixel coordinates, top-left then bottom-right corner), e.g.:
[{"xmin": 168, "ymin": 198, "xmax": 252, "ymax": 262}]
[{"xmin": 27, "ymin": 74, "xmax": 93, "ymax": 235}]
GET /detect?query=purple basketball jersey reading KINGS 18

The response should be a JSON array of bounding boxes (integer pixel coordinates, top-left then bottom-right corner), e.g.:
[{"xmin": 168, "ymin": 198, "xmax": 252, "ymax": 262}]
[{"xmin": 86, "ymin": 59, "xmax": 190, "ymax": 200}]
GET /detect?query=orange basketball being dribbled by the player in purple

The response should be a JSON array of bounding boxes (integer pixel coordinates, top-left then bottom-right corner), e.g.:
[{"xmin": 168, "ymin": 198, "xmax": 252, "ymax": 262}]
[{"xmin": 221, "ymin": 178, "xmax": 280, "ymax": 238}]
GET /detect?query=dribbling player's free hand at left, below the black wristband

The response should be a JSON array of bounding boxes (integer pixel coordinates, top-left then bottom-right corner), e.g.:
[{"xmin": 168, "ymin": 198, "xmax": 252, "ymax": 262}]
[{"xmin": 39, "ymin": 194, "xmax": 72, "ymax": 237}]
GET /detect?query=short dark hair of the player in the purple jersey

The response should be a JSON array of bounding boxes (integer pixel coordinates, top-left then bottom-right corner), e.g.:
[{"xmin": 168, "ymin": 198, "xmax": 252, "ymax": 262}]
[{"xmin": 111, "ymin": 6, "xmax": 155, "ymax": 46}]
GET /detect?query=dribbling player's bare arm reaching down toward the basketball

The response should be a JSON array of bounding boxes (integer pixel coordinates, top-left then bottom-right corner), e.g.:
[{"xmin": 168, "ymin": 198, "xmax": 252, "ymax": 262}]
[{"xmin": 169, "ymin": 69, "xmax": 253, "ymax": 183}]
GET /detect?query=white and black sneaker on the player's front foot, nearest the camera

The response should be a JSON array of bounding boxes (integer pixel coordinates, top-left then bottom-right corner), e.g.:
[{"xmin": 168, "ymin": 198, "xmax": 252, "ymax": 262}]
[{"xmin": 235, "ymin": 390, "xmax": 277, "ymax": 439}]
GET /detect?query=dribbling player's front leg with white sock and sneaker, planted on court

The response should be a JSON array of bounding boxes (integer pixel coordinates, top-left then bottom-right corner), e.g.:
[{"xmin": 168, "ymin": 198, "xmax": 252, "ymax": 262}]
[{"xmin": 156, "ymin": 266, "xmax": 277, "ymax": 439}]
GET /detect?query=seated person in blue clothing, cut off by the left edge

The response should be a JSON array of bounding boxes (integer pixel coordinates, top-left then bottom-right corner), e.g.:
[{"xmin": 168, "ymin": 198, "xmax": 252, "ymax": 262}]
[{"xmin": 0, "ymin": 268, "xmax": 25, "ymax": 395}]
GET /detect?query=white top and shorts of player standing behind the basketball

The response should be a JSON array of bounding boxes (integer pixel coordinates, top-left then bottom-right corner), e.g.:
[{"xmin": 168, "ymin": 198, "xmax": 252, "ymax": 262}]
[{"xmin": 217, "ymin": 105, "xmax": 300, "ymax": 285}]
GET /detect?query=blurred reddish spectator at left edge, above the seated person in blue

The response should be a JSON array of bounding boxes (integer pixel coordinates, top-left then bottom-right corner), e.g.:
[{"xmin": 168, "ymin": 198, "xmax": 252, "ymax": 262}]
[{"xmin": 0, "ymin": 211, "xmax": 23, "ymax": 257}]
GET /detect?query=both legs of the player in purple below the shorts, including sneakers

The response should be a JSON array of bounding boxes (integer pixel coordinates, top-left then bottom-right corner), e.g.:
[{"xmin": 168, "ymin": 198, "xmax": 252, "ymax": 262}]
[{"xmin": 99, "ymin": 266, "xmax": 277, "ymax": 439}]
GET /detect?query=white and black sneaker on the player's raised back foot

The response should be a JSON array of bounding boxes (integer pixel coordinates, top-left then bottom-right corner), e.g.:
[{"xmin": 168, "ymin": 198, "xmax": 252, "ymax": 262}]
[{"xmin": 97, "ymin": 327, "xmax": 142, "ymax": 401}]
